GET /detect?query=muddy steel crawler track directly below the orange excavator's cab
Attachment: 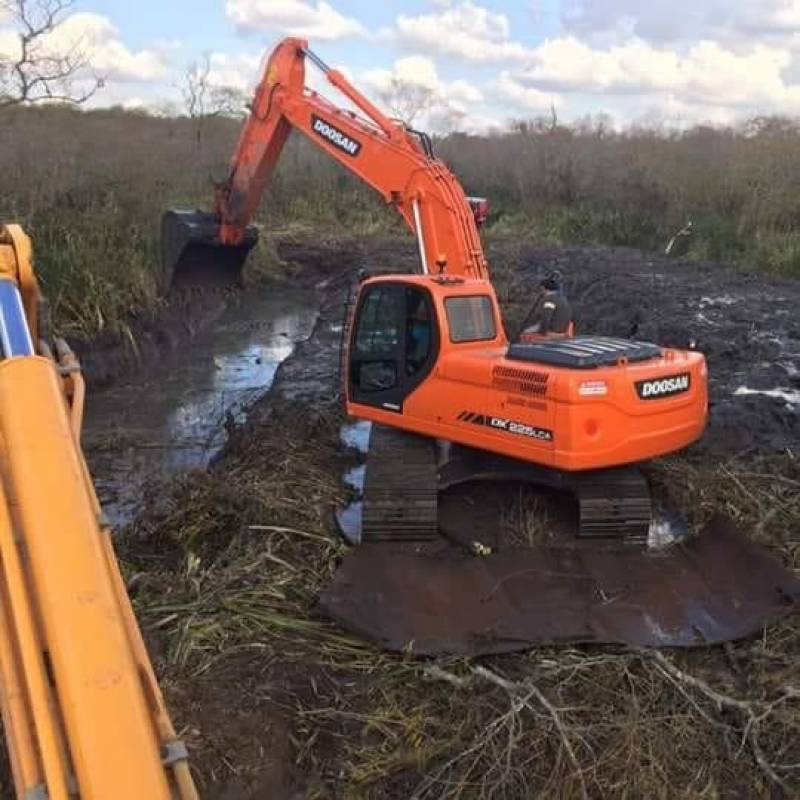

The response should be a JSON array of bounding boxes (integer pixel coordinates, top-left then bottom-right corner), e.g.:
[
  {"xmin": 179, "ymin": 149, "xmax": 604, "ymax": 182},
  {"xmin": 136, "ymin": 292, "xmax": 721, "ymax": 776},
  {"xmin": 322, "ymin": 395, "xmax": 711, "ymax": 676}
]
[{"xmin": 362, "ymin": 424, "xmax": 438, "ymax": 543}]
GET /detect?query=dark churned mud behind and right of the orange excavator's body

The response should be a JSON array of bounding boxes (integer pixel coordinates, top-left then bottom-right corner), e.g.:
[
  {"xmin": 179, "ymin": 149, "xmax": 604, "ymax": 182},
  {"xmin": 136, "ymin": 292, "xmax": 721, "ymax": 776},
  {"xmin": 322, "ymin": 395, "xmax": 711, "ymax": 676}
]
[{"xmin": 500, "ymin": 248, "xmax": 800, "ymax": 455}]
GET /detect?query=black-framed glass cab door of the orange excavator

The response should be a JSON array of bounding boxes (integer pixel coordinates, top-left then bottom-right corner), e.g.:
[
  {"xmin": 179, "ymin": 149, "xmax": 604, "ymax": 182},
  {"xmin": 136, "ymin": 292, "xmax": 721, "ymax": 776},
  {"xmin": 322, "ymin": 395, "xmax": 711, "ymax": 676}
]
[{"xmin": 347, "ymin": 281, "xmax": 439, "ymax": 413}]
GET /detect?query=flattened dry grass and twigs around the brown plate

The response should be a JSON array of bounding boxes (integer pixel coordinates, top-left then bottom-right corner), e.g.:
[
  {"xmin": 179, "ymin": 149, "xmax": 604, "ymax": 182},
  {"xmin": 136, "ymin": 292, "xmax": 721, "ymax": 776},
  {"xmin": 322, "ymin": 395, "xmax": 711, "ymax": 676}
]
[{"xmin": 119, "ymin": 404, "xmax": 800, "ymax": 800}]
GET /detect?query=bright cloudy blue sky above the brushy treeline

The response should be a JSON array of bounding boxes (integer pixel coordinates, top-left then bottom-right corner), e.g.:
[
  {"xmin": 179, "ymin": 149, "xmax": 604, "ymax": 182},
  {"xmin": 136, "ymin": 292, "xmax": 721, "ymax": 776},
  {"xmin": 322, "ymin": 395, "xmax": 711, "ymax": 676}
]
[{"xmin": 0, "ymin": 0, "xmax": 800, "ymax": 132}]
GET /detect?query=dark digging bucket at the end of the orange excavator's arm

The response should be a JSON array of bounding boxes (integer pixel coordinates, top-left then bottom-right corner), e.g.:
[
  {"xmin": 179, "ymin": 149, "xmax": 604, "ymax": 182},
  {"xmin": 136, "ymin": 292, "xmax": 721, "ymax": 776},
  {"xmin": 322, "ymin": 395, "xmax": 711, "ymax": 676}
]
[{"xmin": 161, "ymin": 210, "xmax": 258, "ymax": 291}]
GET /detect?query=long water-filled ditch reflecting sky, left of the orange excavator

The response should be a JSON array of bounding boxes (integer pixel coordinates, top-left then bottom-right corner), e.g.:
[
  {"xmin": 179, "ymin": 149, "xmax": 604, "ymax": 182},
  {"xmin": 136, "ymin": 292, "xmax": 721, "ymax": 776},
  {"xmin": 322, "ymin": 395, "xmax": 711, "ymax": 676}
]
[{"xmin": 84, "ymin": 290, "xmax": 318, "ymax": 525}]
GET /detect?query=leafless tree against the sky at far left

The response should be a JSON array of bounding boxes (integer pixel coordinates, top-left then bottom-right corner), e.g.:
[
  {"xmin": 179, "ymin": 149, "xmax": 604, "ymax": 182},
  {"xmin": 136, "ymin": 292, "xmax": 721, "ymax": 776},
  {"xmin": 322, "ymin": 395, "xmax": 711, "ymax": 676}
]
[{"xmin": 0, "ymin": 0, "xmax": 103, "ymax": 109}]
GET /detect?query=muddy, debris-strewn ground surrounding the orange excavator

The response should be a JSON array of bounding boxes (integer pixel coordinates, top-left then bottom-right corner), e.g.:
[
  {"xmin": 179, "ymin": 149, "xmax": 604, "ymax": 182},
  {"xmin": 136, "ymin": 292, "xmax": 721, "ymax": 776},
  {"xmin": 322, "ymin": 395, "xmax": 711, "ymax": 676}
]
[{"xmin": 98, "ymin": 239, "xmax": 800, "ymax": 798}]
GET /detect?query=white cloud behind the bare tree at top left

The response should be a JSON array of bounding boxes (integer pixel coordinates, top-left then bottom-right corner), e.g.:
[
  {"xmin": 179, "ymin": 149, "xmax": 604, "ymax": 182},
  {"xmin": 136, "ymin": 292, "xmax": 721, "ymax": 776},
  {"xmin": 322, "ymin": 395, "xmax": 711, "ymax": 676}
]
[{"xmin": 0, "ymin": 12, "xmax": 167, "ymax": 82}]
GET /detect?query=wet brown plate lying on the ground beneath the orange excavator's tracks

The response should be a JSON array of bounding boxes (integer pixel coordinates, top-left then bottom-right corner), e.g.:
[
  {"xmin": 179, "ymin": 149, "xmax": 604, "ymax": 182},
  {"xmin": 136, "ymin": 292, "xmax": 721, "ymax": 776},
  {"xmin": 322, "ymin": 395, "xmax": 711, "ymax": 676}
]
[{"xmin": 320, "ymin": 517, "xmax": 800, "ymax": 655}]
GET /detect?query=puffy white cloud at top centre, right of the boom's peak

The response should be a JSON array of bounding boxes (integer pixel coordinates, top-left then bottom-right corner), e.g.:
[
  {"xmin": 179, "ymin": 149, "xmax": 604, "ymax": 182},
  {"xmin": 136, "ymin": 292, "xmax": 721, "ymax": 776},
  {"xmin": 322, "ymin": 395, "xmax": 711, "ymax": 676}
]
[{"xmin": 388, "ymin": 0, "xmax": 527, "ymax": 63}]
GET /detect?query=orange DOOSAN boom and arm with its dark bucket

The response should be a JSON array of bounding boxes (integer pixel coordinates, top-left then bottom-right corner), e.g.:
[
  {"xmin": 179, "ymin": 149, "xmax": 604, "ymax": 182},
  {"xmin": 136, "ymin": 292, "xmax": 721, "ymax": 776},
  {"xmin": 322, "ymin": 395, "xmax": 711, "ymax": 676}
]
[{"xmin": 162, "ymin": 39, "xmax": 488, "ymax": 285}]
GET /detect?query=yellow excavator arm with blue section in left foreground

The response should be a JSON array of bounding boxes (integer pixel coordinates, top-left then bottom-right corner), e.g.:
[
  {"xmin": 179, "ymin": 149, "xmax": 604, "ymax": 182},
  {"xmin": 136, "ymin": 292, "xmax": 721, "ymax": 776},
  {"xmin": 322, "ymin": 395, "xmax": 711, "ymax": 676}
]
[{"xmin": 0, "ymin": 225, "xmax": 197, "ymax": 800}]
